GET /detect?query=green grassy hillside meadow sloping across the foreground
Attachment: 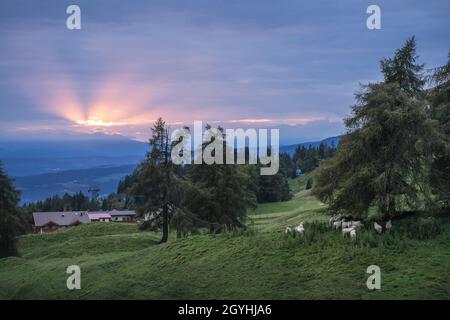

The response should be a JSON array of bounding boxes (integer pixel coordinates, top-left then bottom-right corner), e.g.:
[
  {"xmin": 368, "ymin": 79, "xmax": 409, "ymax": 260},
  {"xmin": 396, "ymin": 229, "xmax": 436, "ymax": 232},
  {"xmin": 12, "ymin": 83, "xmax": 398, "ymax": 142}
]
[{"xmin": 0, "ymin": 177, "xmax": 450, "ymax": 299}]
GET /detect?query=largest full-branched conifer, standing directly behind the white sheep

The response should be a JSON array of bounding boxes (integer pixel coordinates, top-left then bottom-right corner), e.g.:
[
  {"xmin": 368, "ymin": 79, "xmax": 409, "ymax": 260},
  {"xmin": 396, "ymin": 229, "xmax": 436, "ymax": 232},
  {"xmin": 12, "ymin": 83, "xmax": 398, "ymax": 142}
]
[{"xmin": 314, "ymin": 38, "xmax": 440, "ymax": 218}]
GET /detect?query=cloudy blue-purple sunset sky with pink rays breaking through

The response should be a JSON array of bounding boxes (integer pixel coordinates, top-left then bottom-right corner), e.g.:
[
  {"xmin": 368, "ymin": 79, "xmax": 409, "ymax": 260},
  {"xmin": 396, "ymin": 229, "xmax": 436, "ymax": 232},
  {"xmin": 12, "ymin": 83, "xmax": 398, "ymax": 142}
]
[{"xmin": 0, "ymin": 0, "xmax": 450, "ymax": 144}]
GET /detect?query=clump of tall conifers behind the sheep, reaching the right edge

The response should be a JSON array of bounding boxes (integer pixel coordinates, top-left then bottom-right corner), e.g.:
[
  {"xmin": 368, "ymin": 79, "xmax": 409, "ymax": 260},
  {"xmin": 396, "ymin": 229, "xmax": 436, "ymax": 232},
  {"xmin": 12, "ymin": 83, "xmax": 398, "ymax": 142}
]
[{"xmin": 314, "ymin": 37, "xmax": 450, "ymax": 219}]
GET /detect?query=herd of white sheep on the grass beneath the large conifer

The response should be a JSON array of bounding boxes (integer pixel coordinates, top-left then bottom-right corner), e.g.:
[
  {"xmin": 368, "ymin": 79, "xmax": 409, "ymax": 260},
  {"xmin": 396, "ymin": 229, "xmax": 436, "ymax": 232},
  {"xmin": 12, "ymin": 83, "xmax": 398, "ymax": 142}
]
[{"xmin": 285, "ymin": 216, "xmax": 392, "ymax": 241}]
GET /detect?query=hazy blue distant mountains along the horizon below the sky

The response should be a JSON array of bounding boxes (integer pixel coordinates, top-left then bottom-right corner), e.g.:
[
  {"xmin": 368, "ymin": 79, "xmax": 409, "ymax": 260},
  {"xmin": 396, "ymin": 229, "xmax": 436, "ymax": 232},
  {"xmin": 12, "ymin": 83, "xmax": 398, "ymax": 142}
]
[{"xmin": 0, "ymin": 137, "xmax": 339, "ymax": 203}]
